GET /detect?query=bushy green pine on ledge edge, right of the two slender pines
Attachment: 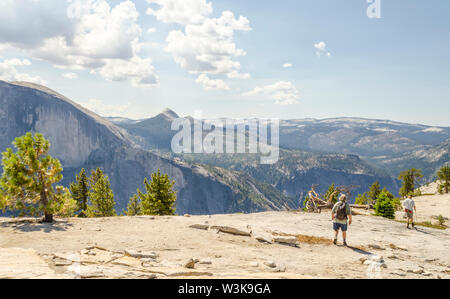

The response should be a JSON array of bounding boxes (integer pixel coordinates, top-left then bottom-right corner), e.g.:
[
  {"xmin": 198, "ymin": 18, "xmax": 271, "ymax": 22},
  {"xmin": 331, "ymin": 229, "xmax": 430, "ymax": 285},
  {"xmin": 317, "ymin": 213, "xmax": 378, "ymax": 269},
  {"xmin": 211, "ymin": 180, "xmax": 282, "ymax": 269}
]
[{"xmin": 137, "ymin": 169, "xmax": 177, "ymax": 216}]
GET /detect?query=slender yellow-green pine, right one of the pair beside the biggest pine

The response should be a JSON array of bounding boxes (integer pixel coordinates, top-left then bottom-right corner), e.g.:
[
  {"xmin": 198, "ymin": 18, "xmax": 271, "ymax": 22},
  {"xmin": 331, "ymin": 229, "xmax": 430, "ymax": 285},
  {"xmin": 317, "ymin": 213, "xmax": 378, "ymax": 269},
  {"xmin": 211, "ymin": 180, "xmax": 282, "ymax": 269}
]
[{"xmin": 86, "ymin": 168, "xmax": 117, "ymax": 218}]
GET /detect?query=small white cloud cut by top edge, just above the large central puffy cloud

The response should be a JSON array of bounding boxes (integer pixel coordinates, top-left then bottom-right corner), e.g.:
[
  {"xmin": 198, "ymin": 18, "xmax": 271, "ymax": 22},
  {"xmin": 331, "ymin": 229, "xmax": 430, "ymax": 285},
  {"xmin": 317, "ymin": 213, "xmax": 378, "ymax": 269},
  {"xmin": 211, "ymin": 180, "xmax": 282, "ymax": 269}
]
[{"xmin": 147, "ymin": 0, "xmax": 213, "ymax": 25}]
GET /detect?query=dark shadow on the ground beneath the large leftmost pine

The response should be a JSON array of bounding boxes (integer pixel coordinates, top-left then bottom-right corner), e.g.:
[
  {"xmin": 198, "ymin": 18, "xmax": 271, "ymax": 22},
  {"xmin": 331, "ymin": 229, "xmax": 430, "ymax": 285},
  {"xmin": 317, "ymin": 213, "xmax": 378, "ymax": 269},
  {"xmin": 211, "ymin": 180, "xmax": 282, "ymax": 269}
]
[{"xmin": 0, "ymin": 219, "xmax": 73, "ymax": 233}]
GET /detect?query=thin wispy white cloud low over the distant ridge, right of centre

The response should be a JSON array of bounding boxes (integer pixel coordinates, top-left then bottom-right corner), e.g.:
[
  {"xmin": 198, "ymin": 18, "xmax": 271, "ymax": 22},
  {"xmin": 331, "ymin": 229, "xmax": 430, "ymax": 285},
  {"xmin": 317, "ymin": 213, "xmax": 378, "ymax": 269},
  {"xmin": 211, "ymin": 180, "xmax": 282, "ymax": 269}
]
[{"xmin": 243, "ymin": 81, "xmax": 300, "ymax": 105}]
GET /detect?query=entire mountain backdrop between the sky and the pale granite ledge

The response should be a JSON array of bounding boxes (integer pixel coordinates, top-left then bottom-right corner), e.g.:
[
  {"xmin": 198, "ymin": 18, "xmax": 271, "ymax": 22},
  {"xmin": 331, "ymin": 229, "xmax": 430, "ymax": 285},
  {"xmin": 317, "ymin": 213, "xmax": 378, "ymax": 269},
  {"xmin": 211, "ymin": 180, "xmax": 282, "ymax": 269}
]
[{"xmin": 0, "ymin": 81, "xmax": 444, "ymax": 214}]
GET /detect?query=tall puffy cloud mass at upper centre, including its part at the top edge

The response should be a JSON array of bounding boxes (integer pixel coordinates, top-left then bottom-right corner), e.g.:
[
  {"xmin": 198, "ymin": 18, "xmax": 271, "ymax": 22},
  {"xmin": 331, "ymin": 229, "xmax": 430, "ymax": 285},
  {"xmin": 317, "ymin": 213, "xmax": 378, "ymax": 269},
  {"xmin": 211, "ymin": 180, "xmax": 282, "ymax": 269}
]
[{"xmin": 147, "ymin": 0, "xmax": 251, "ymax": 83}]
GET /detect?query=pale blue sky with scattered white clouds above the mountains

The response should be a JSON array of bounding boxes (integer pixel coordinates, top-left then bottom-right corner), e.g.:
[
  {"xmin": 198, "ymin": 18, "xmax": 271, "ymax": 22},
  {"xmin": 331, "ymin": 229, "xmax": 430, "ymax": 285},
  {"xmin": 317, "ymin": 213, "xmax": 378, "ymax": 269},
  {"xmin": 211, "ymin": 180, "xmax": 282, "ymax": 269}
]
[{"xmin": 0, "ymin": 0, "xmax": 450, "ymax": 126}]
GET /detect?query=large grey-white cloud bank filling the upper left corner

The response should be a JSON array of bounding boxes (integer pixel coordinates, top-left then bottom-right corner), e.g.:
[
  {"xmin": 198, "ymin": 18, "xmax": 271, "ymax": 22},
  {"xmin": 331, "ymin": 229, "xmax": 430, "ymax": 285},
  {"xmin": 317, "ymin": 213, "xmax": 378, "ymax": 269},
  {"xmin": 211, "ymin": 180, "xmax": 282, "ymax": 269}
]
[{"xmin": 0, "ymin": 0, "xmax": 157, "ymax": 86}]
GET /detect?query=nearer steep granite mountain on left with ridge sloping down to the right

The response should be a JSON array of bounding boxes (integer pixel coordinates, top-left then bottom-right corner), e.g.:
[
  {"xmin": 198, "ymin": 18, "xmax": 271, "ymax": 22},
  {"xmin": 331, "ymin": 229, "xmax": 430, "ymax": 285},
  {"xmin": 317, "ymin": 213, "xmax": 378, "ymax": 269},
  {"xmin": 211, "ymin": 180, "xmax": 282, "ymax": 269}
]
[{"xmin": 0, "ymin": 81, "xmax": 295, "ymax": 214}]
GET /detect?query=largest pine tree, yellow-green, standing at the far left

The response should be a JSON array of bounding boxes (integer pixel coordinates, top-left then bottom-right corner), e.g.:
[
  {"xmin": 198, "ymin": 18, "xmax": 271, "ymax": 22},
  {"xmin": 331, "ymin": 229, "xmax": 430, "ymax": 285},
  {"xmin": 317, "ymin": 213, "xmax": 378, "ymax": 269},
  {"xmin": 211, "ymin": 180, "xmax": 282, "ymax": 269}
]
[{"xmin": 0, "ymin": 133, "xmax": 75, "ymax": 222}]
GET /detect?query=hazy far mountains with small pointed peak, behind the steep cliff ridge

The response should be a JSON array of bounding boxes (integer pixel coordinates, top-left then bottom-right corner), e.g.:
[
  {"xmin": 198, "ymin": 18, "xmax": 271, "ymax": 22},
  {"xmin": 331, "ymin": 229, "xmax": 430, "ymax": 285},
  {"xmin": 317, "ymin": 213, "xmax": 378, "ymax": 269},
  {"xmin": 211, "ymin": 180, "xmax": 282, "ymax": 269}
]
[{"xmin": 110, "ymin": 109, "xmax": 450, "ymax": 184}]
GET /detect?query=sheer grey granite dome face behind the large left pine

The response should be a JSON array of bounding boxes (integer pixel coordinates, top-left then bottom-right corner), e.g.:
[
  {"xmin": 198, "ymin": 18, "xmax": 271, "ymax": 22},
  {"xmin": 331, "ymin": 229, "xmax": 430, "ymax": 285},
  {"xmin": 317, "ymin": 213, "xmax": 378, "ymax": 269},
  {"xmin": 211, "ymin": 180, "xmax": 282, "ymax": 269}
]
[{"xmin": 0, "ymin": 82, "xmax": 127, "ymax": 167}]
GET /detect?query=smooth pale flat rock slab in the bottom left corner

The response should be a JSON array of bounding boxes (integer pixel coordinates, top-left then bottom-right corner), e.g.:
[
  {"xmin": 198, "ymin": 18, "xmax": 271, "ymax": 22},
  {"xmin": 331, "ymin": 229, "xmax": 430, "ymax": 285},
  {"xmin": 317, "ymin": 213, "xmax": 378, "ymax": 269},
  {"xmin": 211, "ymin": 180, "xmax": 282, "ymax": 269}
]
[{"xmin": 0, "ymin": 248, "xmax": 70, "ymax": 279}]
